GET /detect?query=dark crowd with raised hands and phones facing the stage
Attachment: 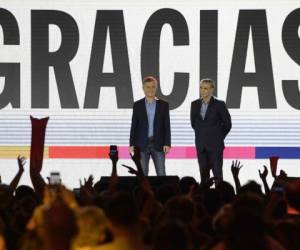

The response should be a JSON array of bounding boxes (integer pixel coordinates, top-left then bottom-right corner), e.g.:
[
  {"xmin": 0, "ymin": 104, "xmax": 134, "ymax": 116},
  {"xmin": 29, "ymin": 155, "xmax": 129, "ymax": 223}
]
[{"xmin": 0, "ymin": 118, "xmax": 300, "ymax": 250}]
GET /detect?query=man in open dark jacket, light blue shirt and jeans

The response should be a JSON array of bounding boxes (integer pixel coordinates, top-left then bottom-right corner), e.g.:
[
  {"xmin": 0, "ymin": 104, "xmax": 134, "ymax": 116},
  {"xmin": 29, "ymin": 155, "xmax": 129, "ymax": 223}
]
[{"xmin": 129, "ymin": 76, "xmax": 171, "ymax": 175}]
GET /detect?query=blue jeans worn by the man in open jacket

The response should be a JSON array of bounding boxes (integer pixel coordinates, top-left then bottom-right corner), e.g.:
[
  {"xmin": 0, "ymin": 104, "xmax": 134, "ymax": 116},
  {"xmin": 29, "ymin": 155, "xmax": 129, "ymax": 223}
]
[{"xmin": 141, "ymin": 142, "xmax": 166, "ymax": 176}]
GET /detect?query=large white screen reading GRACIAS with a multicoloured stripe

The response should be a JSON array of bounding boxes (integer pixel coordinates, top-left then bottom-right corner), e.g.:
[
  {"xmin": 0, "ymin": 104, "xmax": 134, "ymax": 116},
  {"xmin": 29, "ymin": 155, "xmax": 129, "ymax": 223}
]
[{"xmin": 0, "ymin": 0, "xmax": 300, "ymax": 186}]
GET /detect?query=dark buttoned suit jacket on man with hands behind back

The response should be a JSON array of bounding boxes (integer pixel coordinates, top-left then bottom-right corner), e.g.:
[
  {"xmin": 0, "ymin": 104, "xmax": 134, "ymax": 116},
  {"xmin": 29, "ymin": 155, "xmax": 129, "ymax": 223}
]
[{"xmin": 191, "ymin": 97, "xmax": 231, "ymax": 152}]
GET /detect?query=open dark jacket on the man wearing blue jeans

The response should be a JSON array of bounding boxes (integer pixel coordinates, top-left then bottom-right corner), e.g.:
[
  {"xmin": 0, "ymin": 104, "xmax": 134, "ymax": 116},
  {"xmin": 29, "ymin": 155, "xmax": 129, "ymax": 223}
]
[{"xmin": 130, "ymin": 98, "xmax": 171, "ymax": 151}]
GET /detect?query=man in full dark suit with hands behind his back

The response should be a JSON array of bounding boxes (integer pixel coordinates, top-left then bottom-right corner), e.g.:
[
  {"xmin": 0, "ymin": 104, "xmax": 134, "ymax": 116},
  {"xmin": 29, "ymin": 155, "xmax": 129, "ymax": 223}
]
[{"xmin": 191, "ymin": 79, "xmax": 231, "ymax": 182}]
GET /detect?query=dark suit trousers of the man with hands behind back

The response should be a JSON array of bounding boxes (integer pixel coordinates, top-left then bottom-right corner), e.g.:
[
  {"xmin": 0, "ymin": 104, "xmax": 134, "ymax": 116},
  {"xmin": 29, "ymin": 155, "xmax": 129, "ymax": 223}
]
[{"xmin": 197, "ymin": 148, "xmax": 223, "ymax": 182}]
